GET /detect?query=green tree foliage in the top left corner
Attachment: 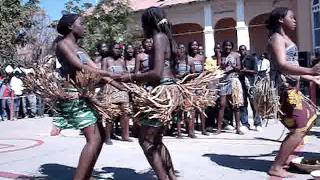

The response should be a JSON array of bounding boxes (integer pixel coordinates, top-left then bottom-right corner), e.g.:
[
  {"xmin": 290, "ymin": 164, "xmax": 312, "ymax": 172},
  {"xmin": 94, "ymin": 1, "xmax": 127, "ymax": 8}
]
[{"xmin": 0, "ymin": 0, "xmax": 39, "ymax": 67}]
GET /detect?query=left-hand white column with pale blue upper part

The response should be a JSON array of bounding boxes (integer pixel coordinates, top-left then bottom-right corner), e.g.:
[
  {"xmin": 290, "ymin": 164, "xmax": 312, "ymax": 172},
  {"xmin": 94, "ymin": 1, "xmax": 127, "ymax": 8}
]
[{"xmin": 203, "ymin": 3, "xmax": 215, "ymax": 57}]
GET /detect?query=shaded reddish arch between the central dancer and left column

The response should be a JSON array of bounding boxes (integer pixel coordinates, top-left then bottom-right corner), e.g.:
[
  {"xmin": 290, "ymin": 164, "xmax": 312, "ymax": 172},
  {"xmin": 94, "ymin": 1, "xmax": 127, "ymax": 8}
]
[{"xmin": 172, "ymin": 23, "xmax": 204, "ymax": 46}]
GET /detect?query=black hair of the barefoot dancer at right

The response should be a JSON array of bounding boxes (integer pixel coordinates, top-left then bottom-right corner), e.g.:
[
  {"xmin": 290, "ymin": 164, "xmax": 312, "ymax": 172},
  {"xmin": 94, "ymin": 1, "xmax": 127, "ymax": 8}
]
[{"xmin": 266, "ymin": 7, "xmax": 289, "ymax": 34}]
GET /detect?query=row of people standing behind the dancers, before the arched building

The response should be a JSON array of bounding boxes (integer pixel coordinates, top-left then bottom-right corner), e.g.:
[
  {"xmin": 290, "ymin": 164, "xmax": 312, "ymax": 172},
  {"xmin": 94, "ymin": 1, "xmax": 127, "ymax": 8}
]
[{"xmin": 77, "ymin": 38, "xmax": 270, "ymax": 140}]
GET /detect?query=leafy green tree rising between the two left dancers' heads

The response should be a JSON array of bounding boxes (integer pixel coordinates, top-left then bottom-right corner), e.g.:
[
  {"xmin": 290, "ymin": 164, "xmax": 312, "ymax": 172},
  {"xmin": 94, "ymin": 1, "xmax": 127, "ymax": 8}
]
[{"xmin": 64, "ymin": 0, "xmax": 133, "ymax": 55}]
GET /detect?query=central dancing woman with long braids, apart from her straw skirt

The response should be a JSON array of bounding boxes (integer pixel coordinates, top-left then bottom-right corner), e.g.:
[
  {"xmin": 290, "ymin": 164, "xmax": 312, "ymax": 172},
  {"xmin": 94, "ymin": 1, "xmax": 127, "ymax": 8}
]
[{"xmin": 121, "ymin": 7, "xmax": 176, "ymax": 180}]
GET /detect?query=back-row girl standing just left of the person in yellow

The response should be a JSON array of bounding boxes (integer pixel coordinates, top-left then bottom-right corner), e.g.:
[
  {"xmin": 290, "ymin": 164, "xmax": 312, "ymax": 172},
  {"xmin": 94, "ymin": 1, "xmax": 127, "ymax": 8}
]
[{"xmin": 188, "ymin": 41, "xmax": 209, "ymax": 135}]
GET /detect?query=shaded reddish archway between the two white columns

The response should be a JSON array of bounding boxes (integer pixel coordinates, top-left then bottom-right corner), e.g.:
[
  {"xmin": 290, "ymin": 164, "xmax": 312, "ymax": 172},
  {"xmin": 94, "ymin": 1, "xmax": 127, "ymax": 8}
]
[{"xmin": 214, "ymin": 18, "xmax": 238, "ymax": 50}]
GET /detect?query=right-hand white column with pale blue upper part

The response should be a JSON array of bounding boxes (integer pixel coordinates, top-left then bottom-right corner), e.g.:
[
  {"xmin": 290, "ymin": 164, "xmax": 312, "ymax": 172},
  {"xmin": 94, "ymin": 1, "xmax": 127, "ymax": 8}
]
[{"xmin": 236, "ymin": 0, "xmax": 250, "ymax": 50}]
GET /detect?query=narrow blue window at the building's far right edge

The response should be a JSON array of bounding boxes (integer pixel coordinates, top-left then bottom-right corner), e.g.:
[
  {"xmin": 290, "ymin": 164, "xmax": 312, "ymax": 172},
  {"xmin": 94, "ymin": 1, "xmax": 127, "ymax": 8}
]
[{"xmin": 312, "ymin": 0, "xmax": 320, "ymax": 50}]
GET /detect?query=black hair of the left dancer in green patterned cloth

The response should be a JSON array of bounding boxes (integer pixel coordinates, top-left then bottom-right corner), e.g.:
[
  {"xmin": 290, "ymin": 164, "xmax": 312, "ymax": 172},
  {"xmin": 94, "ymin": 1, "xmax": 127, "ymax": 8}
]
[{"xmin": 57, "ymin": 14, "xmax": 79, "ymax": 36}]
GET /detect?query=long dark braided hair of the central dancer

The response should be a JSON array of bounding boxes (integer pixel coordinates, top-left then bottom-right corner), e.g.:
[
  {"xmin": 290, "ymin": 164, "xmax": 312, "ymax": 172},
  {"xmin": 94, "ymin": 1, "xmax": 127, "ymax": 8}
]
[{"xmin": 141, "ymin": 7, "xmax": 176, "ymax": 60}]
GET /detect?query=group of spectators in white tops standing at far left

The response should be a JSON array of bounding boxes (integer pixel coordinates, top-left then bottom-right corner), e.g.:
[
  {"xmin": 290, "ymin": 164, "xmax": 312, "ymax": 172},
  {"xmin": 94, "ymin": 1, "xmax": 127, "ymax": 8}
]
[{"xmin": 0, "ymin": 65, "xmax": 45, "ymax": 121}]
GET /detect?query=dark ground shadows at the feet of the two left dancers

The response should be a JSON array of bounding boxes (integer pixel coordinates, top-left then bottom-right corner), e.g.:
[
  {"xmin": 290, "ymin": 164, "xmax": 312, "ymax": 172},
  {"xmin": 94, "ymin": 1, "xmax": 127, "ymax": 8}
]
[{"xmin": 34, "ymin": 164, "xmax": 155, "ymax": 180}]
